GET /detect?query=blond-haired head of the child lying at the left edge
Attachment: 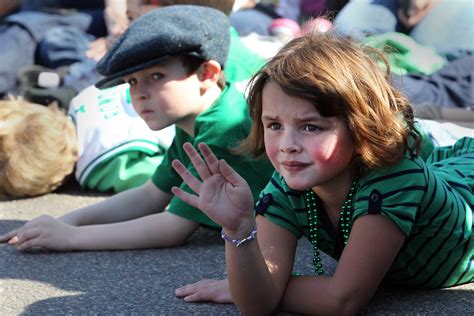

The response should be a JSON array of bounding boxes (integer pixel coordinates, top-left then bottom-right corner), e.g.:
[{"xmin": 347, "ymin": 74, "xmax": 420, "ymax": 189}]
[{"xmin": 0, "ymin": 100, "xmax": 78, "ymax": 197}]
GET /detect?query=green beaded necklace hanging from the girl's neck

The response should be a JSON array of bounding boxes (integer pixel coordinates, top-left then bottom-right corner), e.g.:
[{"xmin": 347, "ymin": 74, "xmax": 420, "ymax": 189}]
[{"xmin": 304, "ymin": 180, "xmax": 357, "ymax": 275}]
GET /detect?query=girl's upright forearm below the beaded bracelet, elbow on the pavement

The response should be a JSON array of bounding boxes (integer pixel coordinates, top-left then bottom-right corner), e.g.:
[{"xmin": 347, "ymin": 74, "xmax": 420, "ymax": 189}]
[{"xmin": 226, "ymin": 216, "xmax": 297, "ymax": 315}]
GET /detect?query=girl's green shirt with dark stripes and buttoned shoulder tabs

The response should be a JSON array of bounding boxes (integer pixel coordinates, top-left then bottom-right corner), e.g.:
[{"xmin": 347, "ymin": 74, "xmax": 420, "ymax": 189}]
[{"xmin": 256, "ymin": 138, "xmax": 474, "ymax": 288}]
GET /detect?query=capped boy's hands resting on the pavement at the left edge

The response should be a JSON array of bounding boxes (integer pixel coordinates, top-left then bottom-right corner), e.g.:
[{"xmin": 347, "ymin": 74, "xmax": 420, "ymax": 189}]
[{"xmin": 0, "ymin": 215, "xmax": 74, "ymax": 251}]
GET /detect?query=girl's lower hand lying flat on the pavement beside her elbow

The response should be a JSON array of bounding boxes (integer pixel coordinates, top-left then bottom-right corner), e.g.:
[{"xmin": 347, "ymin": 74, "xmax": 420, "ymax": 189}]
[{"xmin": 175, "ymin": 279, "xmax": 234, "ymax": 304}]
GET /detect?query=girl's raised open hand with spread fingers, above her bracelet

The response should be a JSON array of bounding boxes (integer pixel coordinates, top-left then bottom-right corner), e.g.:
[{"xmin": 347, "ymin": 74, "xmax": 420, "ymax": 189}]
[{"xmin": 172, "ymin": 143, "xmax": 254, "ymax": 234}]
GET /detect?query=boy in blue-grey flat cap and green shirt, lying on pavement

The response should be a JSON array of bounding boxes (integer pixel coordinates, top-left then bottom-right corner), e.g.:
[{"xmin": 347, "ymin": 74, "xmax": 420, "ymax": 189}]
[{"xmin": 0, "ymin": 5, "xmax": 273, "ymax": 251}]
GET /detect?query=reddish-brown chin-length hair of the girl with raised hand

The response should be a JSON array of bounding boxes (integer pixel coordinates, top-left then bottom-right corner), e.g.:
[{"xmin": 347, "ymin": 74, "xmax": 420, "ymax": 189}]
[{"xmin": 243, "ymin": 33, "xmax": 419, "ymax": 172}]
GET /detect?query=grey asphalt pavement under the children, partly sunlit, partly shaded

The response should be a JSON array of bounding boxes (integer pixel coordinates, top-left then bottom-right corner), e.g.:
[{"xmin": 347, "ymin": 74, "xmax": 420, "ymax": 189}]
[{"xmin": 0, "ymin": 184, "xmax": 474, "ymax": 316}]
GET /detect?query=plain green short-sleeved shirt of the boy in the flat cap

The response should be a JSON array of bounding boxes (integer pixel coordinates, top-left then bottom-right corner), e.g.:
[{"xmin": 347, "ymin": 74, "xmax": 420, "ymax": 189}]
[{"xmin": 152, "ymin": 84, "xmax": 273, "ymax": 227}]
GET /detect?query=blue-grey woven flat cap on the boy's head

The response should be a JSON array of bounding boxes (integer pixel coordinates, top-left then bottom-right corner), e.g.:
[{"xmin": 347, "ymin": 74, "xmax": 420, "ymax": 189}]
[{"xmin": 96, "ymin": 5, "xmax": 230, "ymax": 88}]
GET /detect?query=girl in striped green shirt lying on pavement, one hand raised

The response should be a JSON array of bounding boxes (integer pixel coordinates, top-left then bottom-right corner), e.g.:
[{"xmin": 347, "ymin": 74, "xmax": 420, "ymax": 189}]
[{"xmin": 173, "ymin": 34, "xmax": 474, "ymax": 315}]
